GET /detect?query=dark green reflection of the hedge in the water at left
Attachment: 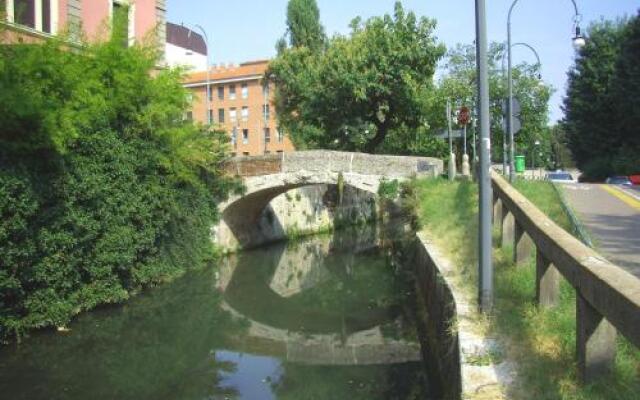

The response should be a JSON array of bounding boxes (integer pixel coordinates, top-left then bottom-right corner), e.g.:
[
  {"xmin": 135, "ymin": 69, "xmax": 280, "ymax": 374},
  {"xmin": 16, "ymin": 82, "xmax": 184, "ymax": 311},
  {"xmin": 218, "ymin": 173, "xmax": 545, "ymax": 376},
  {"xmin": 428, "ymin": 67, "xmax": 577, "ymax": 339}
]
[{"xmin": 0, "ymin": 270, "xmax": 241, "ymax": 400}]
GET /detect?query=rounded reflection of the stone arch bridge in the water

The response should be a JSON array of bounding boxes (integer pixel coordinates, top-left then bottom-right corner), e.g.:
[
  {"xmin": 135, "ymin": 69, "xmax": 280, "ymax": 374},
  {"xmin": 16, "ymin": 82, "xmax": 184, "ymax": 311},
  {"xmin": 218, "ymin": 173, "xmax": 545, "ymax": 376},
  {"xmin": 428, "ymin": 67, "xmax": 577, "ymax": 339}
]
[{"xmin": 218, "ymin": 225, "xmax": 421, "ymax": 365}]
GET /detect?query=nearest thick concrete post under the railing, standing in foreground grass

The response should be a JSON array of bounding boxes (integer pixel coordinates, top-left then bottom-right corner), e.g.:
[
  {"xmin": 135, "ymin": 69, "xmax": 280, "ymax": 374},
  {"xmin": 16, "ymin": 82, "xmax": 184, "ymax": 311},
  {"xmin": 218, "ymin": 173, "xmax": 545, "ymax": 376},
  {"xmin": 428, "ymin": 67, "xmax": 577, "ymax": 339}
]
[{"xmin": 576, "ymin": 291, "xmax": 616, "ymax": 384}]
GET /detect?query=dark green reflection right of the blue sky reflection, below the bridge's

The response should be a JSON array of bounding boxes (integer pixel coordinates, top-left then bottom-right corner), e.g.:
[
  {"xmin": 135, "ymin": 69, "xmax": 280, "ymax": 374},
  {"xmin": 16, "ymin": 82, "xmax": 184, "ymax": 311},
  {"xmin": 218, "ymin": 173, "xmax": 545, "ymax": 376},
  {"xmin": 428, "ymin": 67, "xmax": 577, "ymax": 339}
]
[{"xmin": 273, "ymin": 363, "xmax": 430, "ymax": 400}]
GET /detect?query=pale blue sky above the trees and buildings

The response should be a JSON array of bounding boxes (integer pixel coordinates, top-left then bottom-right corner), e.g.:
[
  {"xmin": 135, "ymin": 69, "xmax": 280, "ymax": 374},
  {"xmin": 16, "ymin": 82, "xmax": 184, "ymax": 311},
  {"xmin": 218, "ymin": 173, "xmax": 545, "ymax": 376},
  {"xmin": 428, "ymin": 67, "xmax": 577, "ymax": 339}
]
[{"xmin": 167, "ymin": 0, "xmax": 640, "ymax": 123}]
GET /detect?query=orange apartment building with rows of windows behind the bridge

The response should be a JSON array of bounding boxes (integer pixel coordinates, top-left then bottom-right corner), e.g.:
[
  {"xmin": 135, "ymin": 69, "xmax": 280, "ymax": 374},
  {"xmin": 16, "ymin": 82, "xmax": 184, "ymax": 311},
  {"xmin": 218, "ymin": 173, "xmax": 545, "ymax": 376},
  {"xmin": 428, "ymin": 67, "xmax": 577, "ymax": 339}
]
[{"xmin": 185, "ymin": 61, "xmax": 294, "ymax": 156}]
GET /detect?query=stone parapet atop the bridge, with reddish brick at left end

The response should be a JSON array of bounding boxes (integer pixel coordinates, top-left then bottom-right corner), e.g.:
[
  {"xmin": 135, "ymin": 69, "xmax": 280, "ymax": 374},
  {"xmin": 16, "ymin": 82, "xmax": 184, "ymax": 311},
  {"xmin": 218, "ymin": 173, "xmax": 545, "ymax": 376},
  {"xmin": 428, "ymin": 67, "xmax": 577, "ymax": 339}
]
[{"xmin": 225, "ymin": 150, "xmax": 443, "ymax": 178}]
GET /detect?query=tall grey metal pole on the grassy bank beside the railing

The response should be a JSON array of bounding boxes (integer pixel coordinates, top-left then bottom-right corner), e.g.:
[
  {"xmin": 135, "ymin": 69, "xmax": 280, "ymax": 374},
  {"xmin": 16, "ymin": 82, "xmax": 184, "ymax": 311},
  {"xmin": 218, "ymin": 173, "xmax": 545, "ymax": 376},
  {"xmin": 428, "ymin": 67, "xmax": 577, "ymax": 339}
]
[{"xmin": 476, "ymin": 0, "xmax": 493, "ymax": 313}]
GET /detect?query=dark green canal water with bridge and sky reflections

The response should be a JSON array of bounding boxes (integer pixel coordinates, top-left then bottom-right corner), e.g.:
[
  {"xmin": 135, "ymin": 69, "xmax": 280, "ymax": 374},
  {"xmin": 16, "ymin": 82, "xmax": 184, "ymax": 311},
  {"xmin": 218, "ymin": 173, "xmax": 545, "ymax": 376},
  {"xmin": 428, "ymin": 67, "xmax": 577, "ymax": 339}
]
[{"xmin": 0, "ymin": 228, "xmax": 428, "ymax": 400}]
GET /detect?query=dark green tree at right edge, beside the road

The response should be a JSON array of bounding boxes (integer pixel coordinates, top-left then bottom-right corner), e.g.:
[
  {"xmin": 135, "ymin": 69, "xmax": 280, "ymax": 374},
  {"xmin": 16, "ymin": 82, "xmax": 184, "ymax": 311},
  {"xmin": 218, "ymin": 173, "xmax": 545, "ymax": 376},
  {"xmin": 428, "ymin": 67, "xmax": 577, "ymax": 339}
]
[{"xmin": 563, "ymin": 16, "xmax": 640, "ymax": 179}]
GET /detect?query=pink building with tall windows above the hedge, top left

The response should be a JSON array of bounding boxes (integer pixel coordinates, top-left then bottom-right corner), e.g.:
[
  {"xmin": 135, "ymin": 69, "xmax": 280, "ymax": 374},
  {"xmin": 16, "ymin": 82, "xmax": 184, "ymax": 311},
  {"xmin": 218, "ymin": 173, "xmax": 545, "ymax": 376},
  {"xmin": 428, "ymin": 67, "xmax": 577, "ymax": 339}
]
[{"xmin": 0, "ymin": 0, "xmax": 166, "ymax": 48}]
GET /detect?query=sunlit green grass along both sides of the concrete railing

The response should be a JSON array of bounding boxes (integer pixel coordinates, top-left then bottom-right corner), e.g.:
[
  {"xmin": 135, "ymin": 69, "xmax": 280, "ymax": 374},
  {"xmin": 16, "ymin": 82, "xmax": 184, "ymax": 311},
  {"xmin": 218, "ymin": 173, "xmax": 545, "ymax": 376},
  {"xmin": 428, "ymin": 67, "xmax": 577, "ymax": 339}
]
[{"xmin": 416, "ymin": 180, "xmax": 640, "ymax": 400}]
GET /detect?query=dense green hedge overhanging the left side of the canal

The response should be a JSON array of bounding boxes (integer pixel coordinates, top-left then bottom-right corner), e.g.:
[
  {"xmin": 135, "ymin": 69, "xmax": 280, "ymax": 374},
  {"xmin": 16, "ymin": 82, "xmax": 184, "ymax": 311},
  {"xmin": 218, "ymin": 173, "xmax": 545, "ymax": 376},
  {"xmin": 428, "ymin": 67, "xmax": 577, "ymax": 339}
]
[{"xmin": 0, "ymin": 23, "xmax": 234, "ymax": 340}]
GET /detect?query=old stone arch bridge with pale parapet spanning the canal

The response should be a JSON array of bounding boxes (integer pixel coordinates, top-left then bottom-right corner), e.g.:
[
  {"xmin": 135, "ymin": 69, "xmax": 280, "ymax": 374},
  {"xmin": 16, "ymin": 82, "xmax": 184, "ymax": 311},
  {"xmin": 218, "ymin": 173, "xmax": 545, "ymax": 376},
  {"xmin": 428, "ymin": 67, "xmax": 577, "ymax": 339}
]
[{"xmin": 212, "ymin": 151, "xmax": 443, "ymax": 250}]
